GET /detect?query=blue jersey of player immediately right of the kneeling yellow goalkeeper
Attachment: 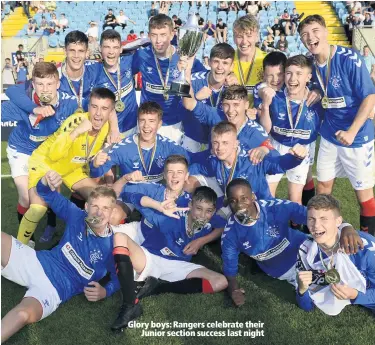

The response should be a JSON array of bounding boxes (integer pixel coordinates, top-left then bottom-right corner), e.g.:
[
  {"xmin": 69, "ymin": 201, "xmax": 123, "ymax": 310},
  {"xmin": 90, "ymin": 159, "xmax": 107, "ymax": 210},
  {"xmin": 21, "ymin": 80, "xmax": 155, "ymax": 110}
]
[{"xmin": 90, "ymin": 134, "xmax": 190, "ymax": 182}]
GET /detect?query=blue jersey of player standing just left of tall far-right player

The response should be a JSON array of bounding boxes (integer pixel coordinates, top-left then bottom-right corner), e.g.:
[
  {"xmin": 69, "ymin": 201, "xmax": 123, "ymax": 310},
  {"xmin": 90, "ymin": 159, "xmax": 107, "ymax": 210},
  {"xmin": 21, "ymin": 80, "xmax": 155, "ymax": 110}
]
[{"xmin": 270, "ymin": 89, "xmax": 323, "ymax": 147}]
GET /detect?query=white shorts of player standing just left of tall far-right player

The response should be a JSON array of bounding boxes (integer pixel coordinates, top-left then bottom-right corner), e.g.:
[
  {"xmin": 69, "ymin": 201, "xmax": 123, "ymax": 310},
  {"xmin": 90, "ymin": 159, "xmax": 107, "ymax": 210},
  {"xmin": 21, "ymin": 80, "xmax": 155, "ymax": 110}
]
[{"xmin": 266, "ymin": 139, "xmax": 315, "ymax": 185}]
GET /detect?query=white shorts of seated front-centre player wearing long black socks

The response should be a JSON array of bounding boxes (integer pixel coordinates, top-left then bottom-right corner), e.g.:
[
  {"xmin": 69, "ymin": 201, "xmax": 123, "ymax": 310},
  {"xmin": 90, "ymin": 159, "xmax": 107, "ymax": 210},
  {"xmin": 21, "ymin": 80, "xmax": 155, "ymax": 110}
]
[{"xmin": 135, "ymin": 247, "xmax": 204, "ymax": 282}]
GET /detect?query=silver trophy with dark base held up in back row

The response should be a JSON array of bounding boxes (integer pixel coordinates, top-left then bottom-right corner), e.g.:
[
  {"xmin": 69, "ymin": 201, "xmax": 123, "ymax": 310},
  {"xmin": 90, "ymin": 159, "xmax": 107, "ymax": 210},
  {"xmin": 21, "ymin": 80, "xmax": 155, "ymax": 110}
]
[{"xmin": 168, "ymin": 13, "xmax": 203, "ymax": 98}]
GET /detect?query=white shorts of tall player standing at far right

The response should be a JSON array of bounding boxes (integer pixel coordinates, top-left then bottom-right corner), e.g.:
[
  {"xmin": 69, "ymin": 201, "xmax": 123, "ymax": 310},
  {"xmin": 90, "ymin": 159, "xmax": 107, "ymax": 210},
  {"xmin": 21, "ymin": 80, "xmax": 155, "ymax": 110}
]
[{"xmin": 317, "ymin": 138, "xmax": 374, "ymax": 190}]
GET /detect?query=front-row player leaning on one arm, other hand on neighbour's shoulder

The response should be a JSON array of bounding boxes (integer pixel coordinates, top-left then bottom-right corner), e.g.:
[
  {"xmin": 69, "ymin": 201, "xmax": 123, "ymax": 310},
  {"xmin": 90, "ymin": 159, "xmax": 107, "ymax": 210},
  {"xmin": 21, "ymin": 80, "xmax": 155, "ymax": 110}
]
[{"xmin": 221, "ymin": 179, "xmax": 360, "ymax": 306}]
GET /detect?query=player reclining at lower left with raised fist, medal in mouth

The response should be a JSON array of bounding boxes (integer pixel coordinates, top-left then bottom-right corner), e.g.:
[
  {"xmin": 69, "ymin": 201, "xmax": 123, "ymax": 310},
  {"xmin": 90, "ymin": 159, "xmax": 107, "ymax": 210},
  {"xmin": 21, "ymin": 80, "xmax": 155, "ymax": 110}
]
[{"xmin": 1, "ymin": 171, "xmax": 119, "ymax": 342}]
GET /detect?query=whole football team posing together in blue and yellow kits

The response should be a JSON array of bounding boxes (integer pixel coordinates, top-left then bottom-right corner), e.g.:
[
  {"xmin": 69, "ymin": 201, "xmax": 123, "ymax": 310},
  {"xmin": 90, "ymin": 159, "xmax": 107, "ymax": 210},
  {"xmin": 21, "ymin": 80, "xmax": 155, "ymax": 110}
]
[{"xmin": 1, "ymin": 14, "xmax": 375, "ymax": 342}]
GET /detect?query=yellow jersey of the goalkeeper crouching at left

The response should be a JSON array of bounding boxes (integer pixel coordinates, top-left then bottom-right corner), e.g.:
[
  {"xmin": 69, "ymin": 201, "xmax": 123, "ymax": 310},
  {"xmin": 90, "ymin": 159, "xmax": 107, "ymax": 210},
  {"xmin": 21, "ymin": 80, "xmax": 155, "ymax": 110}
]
[{"xmin": 30, "ymin": 113, "xmax": 109, "ymax": 176}]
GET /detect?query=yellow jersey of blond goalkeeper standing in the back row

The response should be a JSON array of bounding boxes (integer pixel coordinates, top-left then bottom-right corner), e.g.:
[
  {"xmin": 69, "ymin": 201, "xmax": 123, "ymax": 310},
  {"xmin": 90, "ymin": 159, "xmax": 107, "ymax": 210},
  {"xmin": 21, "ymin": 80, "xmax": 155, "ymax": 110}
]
[{"xmin": 233, "ymin": 48, "xmax": 267, "ymax": 108}]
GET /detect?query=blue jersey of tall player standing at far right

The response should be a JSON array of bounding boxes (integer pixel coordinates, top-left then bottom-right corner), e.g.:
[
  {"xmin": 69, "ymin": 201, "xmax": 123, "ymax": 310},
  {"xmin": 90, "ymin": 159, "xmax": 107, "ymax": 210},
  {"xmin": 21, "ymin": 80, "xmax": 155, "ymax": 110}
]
[{"xmin": 313, "ymin": 46, "xmax": 375, "ymax": 147}]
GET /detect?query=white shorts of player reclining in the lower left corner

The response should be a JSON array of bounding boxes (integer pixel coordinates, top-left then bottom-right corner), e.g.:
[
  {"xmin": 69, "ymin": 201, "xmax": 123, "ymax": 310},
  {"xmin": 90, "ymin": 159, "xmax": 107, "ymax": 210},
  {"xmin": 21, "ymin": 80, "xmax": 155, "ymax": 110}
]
[{"xmin": 1, "ymin": 237, "xmax": 61, "ymax": 319}]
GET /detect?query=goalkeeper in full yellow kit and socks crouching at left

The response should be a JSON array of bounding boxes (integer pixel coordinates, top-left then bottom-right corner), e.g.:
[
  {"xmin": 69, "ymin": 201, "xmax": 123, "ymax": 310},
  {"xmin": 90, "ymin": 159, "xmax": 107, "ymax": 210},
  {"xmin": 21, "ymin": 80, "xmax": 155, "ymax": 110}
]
[{"xmin": 17, "ymin": 88, "xmax": 115, "ymax": 244}]
